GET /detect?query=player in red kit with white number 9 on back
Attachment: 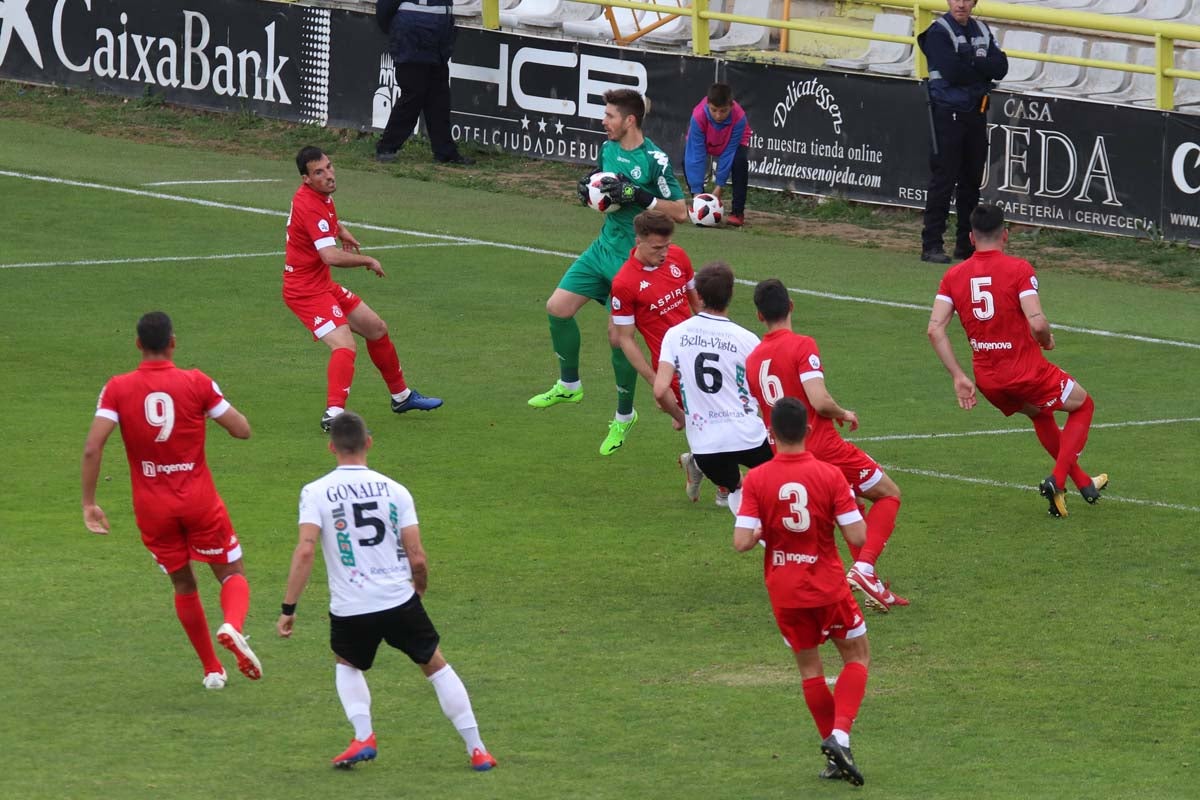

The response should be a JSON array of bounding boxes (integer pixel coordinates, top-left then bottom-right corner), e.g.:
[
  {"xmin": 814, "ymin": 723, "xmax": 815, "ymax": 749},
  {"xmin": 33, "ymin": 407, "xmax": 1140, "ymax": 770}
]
[{"xmin": 80, "ymin": 311, "xmax": 263, "ymax": 688}]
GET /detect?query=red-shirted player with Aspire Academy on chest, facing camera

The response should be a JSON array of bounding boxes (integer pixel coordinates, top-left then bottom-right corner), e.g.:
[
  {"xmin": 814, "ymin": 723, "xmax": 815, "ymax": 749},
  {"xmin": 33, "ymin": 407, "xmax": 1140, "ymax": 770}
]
[{"xmin": 608, "ymin": 211, "xmax": 700, "ymax": 416}]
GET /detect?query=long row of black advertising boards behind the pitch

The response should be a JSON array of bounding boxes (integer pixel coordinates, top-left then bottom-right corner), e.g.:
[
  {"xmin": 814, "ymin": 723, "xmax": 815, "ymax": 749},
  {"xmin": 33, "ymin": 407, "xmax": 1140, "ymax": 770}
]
[{"xmin": 0, "ymin": 0, "xmax": 1200, "ymax": 241}]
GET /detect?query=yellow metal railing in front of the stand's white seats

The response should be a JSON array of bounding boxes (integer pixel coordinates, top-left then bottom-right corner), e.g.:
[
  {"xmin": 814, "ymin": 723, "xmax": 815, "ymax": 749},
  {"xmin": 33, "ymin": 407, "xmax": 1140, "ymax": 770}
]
[{"xmin": 484, "ymin": 0, "xmax": 1200, "ymax": 110}]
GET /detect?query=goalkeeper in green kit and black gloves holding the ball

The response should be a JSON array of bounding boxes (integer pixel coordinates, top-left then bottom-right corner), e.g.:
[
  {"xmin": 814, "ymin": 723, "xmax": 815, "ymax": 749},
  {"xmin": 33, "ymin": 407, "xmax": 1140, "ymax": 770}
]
[{"xmin": 529, "ymin": 89, "xmax": 688, "ymax": 456}]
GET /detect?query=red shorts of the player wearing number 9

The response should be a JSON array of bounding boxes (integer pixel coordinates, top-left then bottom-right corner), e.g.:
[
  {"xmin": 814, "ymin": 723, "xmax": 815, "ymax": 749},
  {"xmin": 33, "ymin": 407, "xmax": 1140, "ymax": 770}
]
[{"xmin": 137, "ymin": 500, "xmax": 241, "ymax": 572}]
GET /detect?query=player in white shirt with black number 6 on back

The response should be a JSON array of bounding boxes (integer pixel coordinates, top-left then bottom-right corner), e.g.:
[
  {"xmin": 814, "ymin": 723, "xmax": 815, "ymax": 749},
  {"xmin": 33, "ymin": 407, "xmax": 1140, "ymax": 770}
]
[{"xmin": 654, "ymin": 261, "xmax": 773, "ymax": 515}]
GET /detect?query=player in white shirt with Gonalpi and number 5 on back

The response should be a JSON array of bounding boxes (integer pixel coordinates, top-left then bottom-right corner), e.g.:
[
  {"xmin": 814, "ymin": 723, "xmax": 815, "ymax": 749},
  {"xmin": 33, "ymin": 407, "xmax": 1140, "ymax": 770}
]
[{"xmin": 276, "ymin": 411, "xmax": 496, "ymax": 771}]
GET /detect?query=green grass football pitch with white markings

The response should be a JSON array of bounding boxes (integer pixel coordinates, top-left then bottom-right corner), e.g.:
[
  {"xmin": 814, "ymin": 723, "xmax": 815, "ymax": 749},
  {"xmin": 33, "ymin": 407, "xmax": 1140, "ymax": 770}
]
[{"xmin": 0, "ymin": 121, "xmax": 1200, "ymax": 800}]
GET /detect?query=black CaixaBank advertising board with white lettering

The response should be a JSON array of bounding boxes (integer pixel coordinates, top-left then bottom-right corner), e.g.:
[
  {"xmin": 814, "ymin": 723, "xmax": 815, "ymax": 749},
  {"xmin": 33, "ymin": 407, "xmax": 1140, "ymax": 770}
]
[{"xmin": 0, "ymin": 0, "xmax": 331, "ymax": 124}]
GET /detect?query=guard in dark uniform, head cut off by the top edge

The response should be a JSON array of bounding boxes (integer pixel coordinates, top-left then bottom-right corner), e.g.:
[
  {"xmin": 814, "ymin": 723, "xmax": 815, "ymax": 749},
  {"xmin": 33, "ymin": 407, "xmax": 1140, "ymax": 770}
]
[{"xmin": 376, "ymin": 0, "xmax": 472, "ymax": 164}]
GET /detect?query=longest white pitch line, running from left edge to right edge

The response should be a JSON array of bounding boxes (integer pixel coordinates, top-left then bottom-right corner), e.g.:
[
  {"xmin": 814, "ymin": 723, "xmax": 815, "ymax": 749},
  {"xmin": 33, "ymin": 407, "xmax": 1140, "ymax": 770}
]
[{"xmin": 7, "ymin": 169, "xmax": 1200, "ymax": 350}]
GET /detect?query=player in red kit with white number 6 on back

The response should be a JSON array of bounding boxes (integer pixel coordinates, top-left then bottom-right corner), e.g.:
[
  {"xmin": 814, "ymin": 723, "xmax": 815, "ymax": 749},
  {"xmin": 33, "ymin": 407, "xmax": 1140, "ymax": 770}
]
[{"xmin": 746, "ymin": 278, "xmax": 908, "ymax": 613}]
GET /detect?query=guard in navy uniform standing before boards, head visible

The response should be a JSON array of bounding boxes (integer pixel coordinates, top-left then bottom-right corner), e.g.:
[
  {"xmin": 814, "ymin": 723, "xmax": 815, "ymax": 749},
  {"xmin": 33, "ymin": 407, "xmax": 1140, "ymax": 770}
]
[{"xmin": 917, "ymin": 0, "xmax": 1008, "ymax": 264}]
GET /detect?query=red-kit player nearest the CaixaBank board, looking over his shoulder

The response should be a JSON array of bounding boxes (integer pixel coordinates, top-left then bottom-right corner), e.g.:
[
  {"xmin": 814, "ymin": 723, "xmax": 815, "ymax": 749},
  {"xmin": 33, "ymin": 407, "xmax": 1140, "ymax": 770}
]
[{"xmin": 283, "ymin": 146, "xmax": 442, "ymax": 431}]
